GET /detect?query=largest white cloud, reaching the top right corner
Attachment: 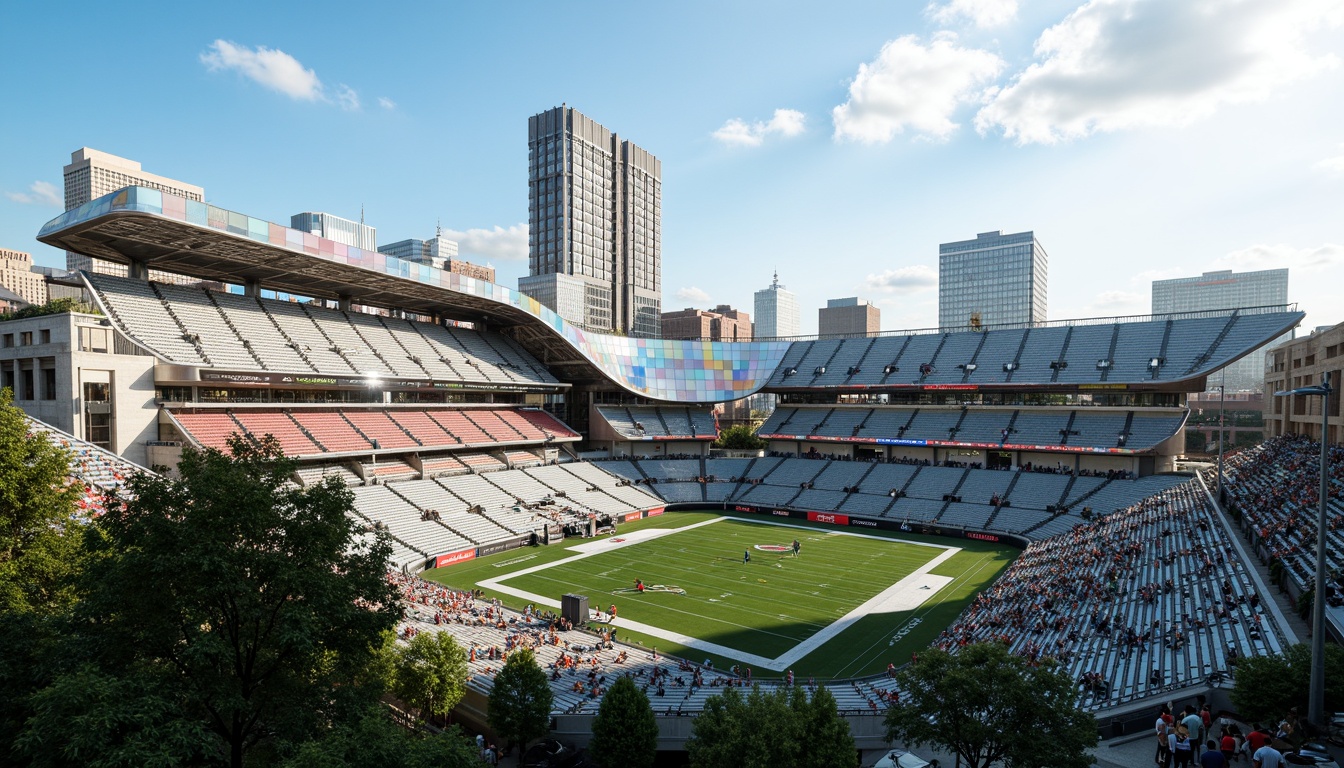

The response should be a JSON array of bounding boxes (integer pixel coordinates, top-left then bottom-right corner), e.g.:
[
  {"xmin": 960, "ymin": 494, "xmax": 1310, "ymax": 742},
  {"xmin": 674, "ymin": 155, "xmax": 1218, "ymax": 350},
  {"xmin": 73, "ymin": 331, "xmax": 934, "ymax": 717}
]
[{"xmin": 976, "ymin": 0, "xmax": 1344, "ymax": 144}]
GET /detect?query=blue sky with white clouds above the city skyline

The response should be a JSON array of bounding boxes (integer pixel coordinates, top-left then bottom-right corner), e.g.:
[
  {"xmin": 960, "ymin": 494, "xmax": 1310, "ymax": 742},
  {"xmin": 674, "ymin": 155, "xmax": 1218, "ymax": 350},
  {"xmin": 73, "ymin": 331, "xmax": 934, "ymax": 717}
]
[{"xmin": 0, "ymin": 0, "xmax": 1344, "ymax": 331}]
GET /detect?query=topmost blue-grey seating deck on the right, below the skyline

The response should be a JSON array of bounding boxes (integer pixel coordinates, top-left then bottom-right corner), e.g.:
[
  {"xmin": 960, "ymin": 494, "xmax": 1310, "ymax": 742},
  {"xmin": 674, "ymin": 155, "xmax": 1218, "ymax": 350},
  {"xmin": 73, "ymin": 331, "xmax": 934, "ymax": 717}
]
[{"xmin": 769, "ymin": 311, "xmax": 1298, "ymax": 389}]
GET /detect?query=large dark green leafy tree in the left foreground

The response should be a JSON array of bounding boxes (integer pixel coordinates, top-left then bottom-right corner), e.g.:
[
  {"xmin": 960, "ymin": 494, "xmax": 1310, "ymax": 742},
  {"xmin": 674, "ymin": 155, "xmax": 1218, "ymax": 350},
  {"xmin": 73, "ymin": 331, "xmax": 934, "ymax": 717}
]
[{"xmin": 23, "ymin": 438, "xmax": 401, "ymax": 768}]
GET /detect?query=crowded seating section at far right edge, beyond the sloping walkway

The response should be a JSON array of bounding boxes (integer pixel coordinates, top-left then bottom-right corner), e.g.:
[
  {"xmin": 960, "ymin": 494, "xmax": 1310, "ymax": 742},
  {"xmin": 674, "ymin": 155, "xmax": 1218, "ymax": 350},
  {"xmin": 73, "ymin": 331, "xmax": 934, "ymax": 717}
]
[{"xmin": 1224, "ymin": 434, "xmax": 1344, "ymax": 605}]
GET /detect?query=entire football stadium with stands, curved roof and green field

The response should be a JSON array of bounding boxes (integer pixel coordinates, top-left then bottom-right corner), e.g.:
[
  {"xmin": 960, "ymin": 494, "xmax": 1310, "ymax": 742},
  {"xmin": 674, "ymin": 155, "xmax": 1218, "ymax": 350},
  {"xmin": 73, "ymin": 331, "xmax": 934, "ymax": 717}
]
[{"xmin": 3, "ymin": 187, "xmax": 1344, "ymax": 749}]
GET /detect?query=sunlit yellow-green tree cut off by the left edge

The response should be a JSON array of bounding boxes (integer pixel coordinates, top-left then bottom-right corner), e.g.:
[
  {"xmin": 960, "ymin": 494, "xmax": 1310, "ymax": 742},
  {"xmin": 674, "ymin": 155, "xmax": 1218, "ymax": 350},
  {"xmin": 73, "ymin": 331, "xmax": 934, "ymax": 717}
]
[{"xmin": 0, "ymin": 389, "xmax": 85, "ymax": 756}]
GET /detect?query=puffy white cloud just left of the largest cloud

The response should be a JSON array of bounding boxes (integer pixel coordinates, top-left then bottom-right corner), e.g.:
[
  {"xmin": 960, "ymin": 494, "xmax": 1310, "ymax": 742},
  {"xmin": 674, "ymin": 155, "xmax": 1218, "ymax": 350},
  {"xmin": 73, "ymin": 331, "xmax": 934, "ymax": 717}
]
[{"xmin": 832, "ymin": 32, "xmax": 1004, "ymax": 144}]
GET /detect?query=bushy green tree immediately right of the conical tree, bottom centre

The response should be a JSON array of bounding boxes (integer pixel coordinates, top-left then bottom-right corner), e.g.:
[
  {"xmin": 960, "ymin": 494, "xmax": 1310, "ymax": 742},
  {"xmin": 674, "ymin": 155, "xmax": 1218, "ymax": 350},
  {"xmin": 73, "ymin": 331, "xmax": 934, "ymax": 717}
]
[{"xmin": 685, "ymin": 686, "xmax": 802, "ymax": 768}]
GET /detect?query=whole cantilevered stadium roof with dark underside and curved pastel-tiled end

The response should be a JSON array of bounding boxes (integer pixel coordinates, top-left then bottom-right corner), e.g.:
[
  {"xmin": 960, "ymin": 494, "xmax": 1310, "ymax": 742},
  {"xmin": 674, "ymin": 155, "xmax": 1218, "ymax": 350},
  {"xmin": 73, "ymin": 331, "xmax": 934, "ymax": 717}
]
[{"xmin": 38, "ymin": 187, "xmax": 789, "ymax": 402}]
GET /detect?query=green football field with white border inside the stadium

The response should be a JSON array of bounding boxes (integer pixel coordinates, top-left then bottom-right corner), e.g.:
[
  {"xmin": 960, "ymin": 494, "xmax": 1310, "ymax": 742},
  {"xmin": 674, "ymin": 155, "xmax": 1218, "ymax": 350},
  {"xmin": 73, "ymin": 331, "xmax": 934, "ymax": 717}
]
[{"xmin": 425, "ymin": 512, "xmax": 1017, "ymax": 678}]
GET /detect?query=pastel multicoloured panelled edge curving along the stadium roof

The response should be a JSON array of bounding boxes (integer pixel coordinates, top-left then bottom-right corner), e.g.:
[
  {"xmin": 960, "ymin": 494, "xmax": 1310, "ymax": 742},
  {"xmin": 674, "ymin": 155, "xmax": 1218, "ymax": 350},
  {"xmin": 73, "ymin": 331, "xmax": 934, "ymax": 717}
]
[{"xmin": 38, "ymin": 187, "xmax": 790, "ymax": 402}]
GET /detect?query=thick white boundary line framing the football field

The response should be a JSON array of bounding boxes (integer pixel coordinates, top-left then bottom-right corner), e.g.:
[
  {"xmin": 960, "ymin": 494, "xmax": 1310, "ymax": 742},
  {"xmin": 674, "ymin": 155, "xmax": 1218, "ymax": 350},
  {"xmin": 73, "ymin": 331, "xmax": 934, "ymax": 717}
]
[{"xmin": 477, "ymin": 516, "xmax": 961, "ymax": 671}]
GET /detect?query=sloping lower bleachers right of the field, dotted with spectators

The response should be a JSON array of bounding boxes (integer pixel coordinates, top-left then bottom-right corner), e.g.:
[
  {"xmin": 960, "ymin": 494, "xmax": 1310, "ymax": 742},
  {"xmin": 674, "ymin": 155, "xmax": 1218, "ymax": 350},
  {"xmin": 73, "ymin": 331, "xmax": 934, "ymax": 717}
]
[{"xmin": 938, "ymin": 482, "xmax": 1285, "ymax": 707}]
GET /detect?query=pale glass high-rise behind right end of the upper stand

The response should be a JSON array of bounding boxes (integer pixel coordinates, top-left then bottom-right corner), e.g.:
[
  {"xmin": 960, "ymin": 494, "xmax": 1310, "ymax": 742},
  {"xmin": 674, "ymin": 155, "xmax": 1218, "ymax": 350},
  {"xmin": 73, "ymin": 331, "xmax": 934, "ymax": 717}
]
[{"xmin": 1153, "ymin": 269, "xmax": 1293, "ymax": 391}]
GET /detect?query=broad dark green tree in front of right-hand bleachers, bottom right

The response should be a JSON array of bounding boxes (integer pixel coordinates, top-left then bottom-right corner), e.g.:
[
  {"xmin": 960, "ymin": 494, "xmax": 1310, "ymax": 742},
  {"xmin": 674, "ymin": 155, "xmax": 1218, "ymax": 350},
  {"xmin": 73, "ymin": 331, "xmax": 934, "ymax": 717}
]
[{"xmin": 886, "ymin": 643, "xmax": 1097, "ymax": 768}]
